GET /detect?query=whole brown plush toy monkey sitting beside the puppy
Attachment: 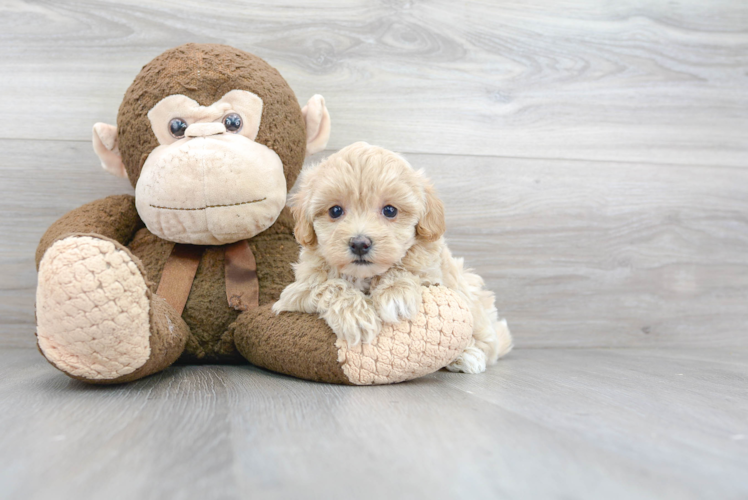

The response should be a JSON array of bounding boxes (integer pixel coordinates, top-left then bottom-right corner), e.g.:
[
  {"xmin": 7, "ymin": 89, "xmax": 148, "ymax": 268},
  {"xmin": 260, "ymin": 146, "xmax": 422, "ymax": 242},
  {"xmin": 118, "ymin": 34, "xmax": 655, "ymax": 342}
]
[{"xmin": 36, "ymin": 44, "xmax": 472, "ymax": 384}]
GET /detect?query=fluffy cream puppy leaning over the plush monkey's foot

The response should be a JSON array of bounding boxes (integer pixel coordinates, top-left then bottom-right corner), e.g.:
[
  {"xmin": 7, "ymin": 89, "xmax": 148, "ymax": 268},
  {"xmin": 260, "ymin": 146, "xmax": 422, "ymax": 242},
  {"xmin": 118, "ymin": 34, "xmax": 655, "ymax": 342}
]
[{"xmin": 273, "ymin": 142, "xmax": 512, "ymax": 373}]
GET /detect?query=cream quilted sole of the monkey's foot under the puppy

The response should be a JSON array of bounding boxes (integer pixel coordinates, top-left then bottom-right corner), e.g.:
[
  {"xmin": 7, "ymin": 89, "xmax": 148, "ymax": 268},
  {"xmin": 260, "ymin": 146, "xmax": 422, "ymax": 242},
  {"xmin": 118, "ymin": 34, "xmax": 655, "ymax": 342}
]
[{"xmin": 335, "ymin": 286, "xmax": 473, "ymax": 385}]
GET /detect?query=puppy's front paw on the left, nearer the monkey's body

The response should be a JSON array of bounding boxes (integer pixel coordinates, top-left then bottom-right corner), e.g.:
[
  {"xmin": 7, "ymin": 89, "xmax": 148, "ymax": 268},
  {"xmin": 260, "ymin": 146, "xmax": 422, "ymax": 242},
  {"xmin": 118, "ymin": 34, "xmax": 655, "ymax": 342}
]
[{"xmin": 322, "ymin": 298, "xmax": 382, "ymax": 346}]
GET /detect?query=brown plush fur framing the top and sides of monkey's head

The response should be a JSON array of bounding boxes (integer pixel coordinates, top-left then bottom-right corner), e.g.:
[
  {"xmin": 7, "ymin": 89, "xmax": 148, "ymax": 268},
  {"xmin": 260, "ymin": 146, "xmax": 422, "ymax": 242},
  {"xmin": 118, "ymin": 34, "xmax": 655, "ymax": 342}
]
[{"xmin": 117, "ymin": 43, "xmax": 306, "ymax": 188}]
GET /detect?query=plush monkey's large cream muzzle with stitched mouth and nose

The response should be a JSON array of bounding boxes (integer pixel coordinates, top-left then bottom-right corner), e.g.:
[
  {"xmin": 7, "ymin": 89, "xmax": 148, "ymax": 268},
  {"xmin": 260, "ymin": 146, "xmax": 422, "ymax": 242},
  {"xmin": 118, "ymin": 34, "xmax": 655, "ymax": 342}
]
[{"xmin": 135, "ymin": 134, "xmax": 287, "ymax": 245}]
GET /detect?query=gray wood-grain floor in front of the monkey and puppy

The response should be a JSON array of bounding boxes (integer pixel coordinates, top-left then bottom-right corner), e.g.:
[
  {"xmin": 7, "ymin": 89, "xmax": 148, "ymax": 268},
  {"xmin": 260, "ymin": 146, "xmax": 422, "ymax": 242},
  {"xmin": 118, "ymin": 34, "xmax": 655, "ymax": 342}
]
[{"xmin": 0, "ymin": 349, "xmax": 748, "ymax": 500}]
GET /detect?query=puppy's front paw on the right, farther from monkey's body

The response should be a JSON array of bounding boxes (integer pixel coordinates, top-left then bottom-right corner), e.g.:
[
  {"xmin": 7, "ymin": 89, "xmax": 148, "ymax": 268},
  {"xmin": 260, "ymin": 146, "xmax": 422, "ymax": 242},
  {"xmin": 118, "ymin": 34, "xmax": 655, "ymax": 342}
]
[{"xmin": 370, "ymin": 268, "xmax": 422, "ymax": 323}]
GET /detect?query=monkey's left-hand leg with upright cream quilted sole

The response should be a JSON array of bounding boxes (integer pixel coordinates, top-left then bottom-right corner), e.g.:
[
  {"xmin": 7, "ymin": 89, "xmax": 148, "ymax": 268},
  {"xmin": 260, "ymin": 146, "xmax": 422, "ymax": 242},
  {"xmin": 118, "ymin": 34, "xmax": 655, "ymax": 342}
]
[{"xmin": 36, "ymin": 235, "xmax": 189, "ymax": 384}]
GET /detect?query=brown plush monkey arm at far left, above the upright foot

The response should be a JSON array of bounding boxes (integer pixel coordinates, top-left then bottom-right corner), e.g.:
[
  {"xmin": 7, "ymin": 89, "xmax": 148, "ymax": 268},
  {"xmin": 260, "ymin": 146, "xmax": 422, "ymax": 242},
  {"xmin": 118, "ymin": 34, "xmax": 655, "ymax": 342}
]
[{"xmin": 36, "ymin": 194, "xmax": 143, "ymax": 269}]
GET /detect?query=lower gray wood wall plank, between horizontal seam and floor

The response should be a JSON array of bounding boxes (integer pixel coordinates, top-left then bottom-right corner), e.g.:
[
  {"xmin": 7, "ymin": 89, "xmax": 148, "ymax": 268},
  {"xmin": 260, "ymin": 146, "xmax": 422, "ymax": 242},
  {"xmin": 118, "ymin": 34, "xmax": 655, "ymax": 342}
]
[{"xmin": 0, "ymin": 140, "xmax": 748, "ymax": 348}]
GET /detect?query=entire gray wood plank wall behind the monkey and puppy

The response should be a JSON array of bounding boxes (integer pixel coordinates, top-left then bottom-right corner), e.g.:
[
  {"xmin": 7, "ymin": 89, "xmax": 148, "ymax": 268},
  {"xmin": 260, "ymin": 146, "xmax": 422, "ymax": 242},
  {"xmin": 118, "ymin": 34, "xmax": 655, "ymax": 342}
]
[{"xmin": 0, "ymin": 0, "xmax": 748, "ymax": 347}]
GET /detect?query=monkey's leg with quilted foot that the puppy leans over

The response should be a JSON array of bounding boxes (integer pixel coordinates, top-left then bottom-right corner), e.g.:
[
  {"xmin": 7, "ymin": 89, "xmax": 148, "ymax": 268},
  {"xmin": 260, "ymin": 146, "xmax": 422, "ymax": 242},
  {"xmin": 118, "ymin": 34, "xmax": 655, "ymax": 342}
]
[{"xmin": 230, "ymin": 286, "xmax": 473, "ymax": 385}]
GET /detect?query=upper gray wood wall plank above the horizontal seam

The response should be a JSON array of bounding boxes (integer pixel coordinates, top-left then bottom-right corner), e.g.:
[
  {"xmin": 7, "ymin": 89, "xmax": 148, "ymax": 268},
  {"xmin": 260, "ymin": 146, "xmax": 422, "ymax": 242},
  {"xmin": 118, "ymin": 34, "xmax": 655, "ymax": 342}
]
[{"xmin": 0, "ymin": 0, "xmax": 748, "ymax": 167}]
